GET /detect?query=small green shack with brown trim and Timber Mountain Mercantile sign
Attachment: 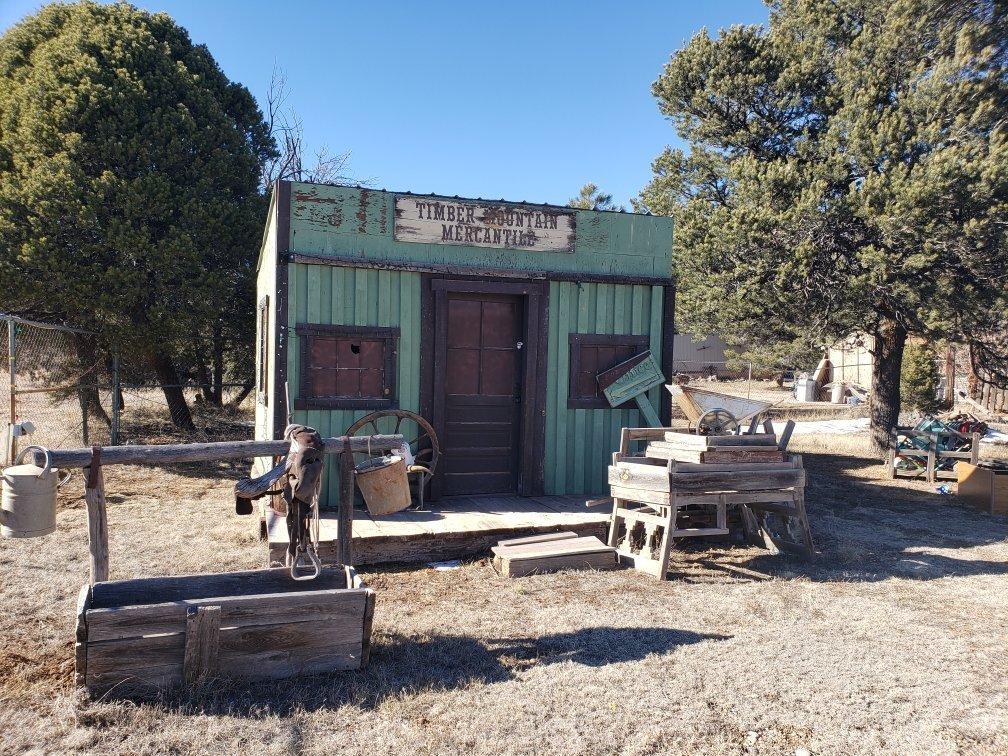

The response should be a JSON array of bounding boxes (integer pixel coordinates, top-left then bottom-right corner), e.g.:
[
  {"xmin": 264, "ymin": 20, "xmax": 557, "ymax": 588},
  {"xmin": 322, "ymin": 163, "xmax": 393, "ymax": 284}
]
[{"xmin": 256, "ymin": 181, "xmax": 674, "ymax": 507}]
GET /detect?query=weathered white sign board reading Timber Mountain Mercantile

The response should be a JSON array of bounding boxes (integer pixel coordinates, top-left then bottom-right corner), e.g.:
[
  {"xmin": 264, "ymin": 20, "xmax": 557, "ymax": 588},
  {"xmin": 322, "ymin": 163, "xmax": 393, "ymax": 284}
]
[{"xmin": 394, "ymin": 196, "xmax": 576, "ymax": 252}]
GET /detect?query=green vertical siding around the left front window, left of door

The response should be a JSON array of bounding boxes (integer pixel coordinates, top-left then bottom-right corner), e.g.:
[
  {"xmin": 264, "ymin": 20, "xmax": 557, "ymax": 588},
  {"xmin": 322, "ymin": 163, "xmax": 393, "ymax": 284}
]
[{"xmin": 279, "ymin": 264, "xmax": 420, "ymax": 507}]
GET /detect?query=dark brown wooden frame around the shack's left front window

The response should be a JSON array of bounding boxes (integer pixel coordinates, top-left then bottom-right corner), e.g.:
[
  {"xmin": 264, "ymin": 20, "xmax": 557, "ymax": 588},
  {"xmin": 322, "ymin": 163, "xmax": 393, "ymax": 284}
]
[{"xmin": 294, "ymin": 323, "xmax": 399, "ymax": 409}]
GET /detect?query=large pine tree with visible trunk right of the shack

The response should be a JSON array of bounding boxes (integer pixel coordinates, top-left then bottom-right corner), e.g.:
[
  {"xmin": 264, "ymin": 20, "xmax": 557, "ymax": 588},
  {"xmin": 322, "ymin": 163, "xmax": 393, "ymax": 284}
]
[{"xmin": 636, "ymin": 0, "xmax": 1008, "ymax": 448}]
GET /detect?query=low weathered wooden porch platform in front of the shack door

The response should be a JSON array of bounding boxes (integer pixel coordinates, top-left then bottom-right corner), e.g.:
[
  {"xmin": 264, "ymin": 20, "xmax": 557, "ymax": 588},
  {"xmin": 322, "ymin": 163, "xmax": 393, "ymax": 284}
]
[{"xmin": 264, "ymin": 496, "xmax": 610, "ymax": 566}]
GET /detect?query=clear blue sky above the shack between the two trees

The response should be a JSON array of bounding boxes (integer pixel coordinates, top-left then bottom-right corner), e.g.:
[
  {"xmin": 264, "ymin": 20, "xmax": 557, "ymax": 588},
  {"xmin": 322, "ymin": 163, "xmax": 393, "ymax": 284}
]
[{"xmin": 0, "ymin": 0, "xmax": 766, "ymax": 204}]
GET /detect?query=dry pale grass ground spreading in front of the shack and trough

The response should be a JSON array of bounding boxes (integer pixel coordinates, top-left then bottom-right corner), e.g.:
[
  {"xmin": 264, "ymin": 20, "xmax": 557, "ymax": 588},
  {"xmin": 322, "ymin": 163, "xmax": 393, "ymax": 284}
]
[{"xmin": 0, "ymin": 436, "xmax": 1008, "ymax": 754}]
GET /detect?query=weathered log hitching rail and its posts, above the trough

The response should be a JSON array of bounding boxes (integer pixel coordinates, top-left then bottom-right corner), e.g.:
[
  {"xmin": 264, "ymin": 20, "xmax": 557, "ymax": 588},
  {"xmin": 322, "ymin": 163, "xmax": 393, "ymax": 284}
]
[{"xmin": 34, "ymin": 434, "xmax": 403, "ymax": 585}]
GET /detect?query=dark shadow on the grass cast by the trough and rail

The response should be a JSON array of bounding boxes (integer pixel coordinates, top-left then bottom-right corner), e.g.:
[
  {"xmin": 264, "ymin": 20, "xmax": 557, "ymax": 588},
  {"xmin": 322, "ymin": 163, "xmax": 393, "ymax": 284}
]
[{"xmin": 140, "ymin": 627, "xmax": 728, "ymax": 719}]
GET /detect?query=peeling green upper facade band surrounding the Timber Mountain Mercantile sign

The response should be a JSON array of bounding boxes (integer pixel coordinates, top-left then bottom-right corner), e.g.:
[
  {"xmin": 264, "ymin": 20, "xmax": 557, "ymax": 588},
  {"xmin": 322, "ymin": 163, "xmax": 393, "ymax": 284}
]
[{"xmin": 290, "ymin": 183, "xmax": 672, "ymax": 277}]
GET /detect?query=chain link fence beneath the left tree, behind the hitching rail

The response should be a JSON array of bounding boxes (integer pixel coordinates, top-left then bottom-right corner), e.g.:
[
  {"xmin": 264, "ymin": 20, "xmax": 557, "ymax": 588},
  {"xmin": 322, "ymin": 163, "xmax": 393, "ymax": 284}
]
[{"xmin": 0, "ymin": 316, "xmax": 255, "ymax": 464}]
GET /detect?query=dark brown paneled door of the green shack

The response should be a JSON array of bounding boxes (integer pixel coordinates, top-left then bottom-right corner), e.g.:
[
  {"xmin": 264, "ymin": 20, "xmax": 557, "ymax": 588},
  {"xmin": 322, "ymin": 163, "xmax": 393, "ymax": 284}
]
[{"xmin": 434, "ymin": 292, "xmax": 524, "ymax": 496}]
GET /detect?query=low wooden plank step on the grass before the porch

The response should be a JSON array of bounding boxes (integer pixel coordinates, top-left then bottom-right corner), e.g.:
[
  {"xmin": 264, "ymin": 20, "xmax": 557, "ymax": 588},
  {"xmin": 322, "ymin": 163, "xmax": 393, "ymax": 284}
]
[{"xmin": 491, "ymin": 531, "xmax": 616, "ymax": 578}]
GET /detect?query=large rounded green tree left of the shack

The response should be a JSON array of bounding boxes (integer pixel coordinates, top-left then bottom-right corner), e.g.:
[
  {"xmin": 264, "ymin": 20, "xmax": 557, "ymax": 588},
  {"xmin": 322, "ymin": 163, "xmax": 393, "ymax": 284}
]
[{"xmin": 0, "ymin": 2, "xmax": 275, "ymax": 427}]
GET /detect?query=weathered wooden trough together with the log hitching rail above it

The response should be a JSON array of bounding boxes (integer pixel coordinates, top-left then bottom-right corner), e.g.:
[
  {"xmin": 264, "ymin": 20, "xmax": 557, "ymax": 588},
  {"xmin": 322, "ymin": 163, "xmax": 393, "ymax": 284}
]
[{"xmin": 28, "ymin": 434, "xmax": 403, "ymax": 698}]
